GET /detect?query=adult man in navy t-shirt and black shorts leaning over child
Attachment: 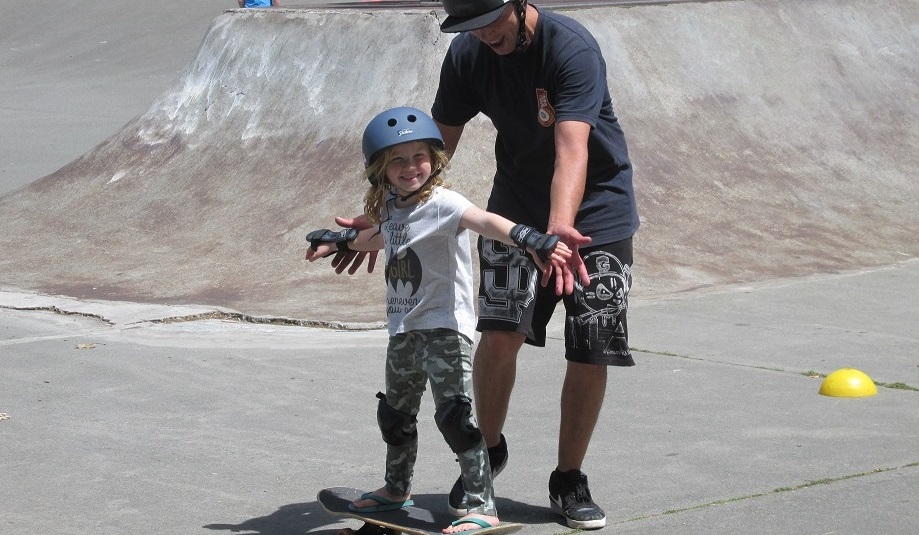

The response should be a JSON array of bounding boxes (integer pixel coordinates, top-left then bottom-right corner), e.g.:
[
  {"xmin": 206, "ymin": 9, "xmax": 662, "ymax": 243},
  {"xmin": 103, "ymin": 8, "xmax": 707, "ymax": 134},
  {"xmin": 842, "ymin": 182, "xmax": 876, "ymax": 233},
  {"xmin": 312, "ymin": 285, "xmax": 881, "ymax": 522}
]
[{"xmin": 432, "ymin": 0, "xmax": 639, "ymax": 529}]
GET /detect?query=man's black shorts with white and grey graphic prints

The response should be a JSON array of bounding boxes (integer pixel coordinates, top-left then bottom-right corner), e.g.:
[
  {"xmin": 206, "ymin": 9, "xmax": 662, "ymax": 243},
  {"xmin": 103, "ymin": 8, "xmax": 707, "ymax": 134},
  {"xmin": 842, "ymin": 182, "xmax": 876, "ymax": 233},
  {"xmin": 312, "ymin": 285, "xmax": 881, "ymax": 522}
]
[{"xmin": 476, "ymin": 237, "xmax": 635, "ymax": 366}]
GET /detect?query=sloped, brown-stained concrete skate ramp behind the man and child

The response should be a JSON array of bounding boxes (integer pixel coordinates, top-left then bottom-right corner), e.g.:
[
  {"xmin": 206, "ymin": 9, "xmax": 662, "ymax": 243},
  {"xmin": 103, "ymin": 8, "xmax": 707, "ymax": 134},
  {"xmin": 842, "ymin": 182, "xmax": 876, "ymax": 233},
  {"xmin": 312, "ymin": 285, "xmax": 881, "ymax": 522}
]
[{"xmin": 0, "ymin": 0, "xmax": 919, "ymax": 322}]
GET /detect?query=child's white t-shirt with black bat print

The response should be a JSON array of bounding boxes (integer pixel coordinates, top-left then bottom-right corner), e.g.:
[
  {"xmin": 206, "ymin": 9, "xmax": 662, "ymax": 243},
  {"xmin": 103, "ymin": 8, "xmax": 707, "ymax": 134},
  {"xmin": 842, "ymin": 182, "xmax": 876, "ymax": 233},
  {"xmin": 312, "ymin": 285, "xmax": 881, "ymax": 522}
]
[{"xmin": 380, "ymin": 187, "xmax": 475, "ymax": 340}]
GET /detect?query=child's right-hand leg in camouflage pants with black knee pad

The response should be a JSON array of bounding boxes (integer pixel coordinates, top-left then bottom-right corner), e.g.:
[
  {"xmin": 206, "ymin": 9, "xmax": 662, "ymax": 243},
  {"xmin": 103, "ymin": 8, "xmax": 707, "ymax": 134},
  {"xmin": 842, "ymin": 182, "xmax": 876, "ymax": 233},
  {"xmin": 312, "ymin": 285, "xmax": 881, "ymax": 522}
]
[{"xmin": 424, "ymin": 329, "xmax": 498, "ymax": 528}]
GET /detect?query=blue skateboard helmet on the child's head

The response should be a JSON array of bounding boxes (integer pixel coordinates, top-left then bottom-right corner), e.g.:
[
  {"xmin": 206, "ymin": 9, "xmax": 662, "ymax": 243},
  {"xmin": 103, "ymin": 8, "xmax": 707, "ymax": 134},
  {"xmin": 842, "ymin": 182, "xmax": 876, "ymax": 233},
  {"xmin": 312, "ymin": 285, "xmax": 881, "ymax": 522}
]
[{"xmin": 362, "ymin": 107, "xmax": 444, "ymax": 167}]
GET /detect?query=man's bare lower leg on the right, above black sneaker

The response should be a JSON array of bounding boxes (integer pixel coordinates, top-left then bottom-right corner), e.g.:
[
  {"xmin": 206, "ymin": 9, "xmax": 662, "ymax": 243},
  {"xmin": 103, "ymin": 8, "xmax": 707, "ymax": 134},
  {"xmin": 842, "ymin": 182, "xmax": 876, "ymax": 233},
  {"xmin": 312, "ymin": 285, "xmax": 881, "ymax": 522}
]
[{"xmin": 556, "ymin": 362, "xmax": 607, "ymax": 472}]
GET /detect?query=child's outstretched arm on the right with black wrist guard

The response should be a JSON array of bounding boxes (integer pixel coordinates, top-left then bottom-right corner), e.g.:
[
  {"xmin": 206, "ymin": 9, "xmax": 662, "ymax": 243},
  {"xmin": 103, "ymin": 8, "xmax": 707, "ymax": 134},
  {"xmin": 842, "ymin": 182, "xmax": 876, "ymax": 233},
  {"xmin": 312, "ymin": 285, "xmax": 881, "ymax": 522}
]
[{"xmin": 460, "ymin": 206, "xmax": 571, "ymax": 294}]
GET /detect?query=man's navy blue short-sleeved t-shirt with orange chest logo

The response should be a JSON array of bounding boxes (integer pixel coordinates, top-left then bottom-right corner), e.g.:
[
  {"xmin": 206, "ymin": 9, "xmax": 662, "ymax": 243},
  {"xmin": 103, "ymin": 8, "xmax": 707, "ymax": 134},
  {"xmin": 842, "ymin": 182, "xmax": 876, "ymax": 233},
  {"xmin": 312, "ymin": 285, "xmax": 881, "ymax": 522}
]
[{"xmin": 431, "ymin": 7, "xmax": 639, "ymax": 245}]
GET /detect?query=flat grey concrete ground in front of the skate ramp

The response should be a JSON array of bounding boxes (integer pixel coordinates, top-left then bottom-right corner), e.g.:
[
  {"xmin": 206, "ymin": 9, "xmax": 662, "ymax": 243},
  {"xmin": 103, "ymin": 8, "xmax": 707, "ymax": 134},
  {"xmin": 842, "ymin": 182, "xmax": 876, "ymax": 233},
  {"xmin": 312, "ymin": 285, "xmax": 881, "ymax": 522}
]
[{"xmin": 0, "ymin": 262, "xmax": 919, "ymax": 535}]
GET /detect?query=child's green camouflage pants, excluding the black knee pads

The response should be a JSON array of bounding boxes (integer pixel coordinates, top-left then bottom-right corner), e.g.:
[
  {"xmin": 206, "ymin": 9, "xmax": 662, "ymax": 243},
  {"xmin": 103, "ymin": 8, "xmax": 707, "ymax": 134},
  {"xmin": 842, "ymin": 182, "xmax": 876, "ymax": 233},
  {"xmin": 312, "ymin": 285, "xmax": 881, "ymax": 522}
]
[{"xmin": 385, "ymin": 329, "xmax": 497, "ymax": 516}]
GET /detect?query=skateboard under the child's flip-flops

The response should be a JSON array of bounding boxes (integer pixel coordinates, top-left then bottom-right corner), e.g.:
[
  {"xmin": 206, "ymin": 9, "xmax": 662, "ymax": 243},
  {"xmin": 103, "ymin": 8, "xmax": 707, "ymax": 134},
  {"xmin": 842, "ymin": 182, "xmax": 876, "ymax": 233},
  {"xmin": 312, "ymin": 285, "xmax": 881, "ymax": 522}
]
[{"xmin": 316, "ymin": 487, "xmax": 523, "ymax": 535}]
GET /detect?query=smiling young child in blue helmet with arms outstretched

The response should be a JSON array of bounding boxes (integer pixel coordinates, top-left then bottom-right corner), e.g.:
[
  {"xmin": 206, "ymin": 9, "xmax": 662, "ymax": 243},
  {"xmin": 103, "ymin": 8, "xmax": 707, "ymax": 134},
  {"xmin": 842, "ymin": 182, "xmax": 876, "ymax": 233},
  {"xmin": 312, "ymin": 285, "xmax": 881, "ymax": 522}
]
[{"xmin": 306, "ymin": 107, "xmax": 571, "ymax": 533}]
